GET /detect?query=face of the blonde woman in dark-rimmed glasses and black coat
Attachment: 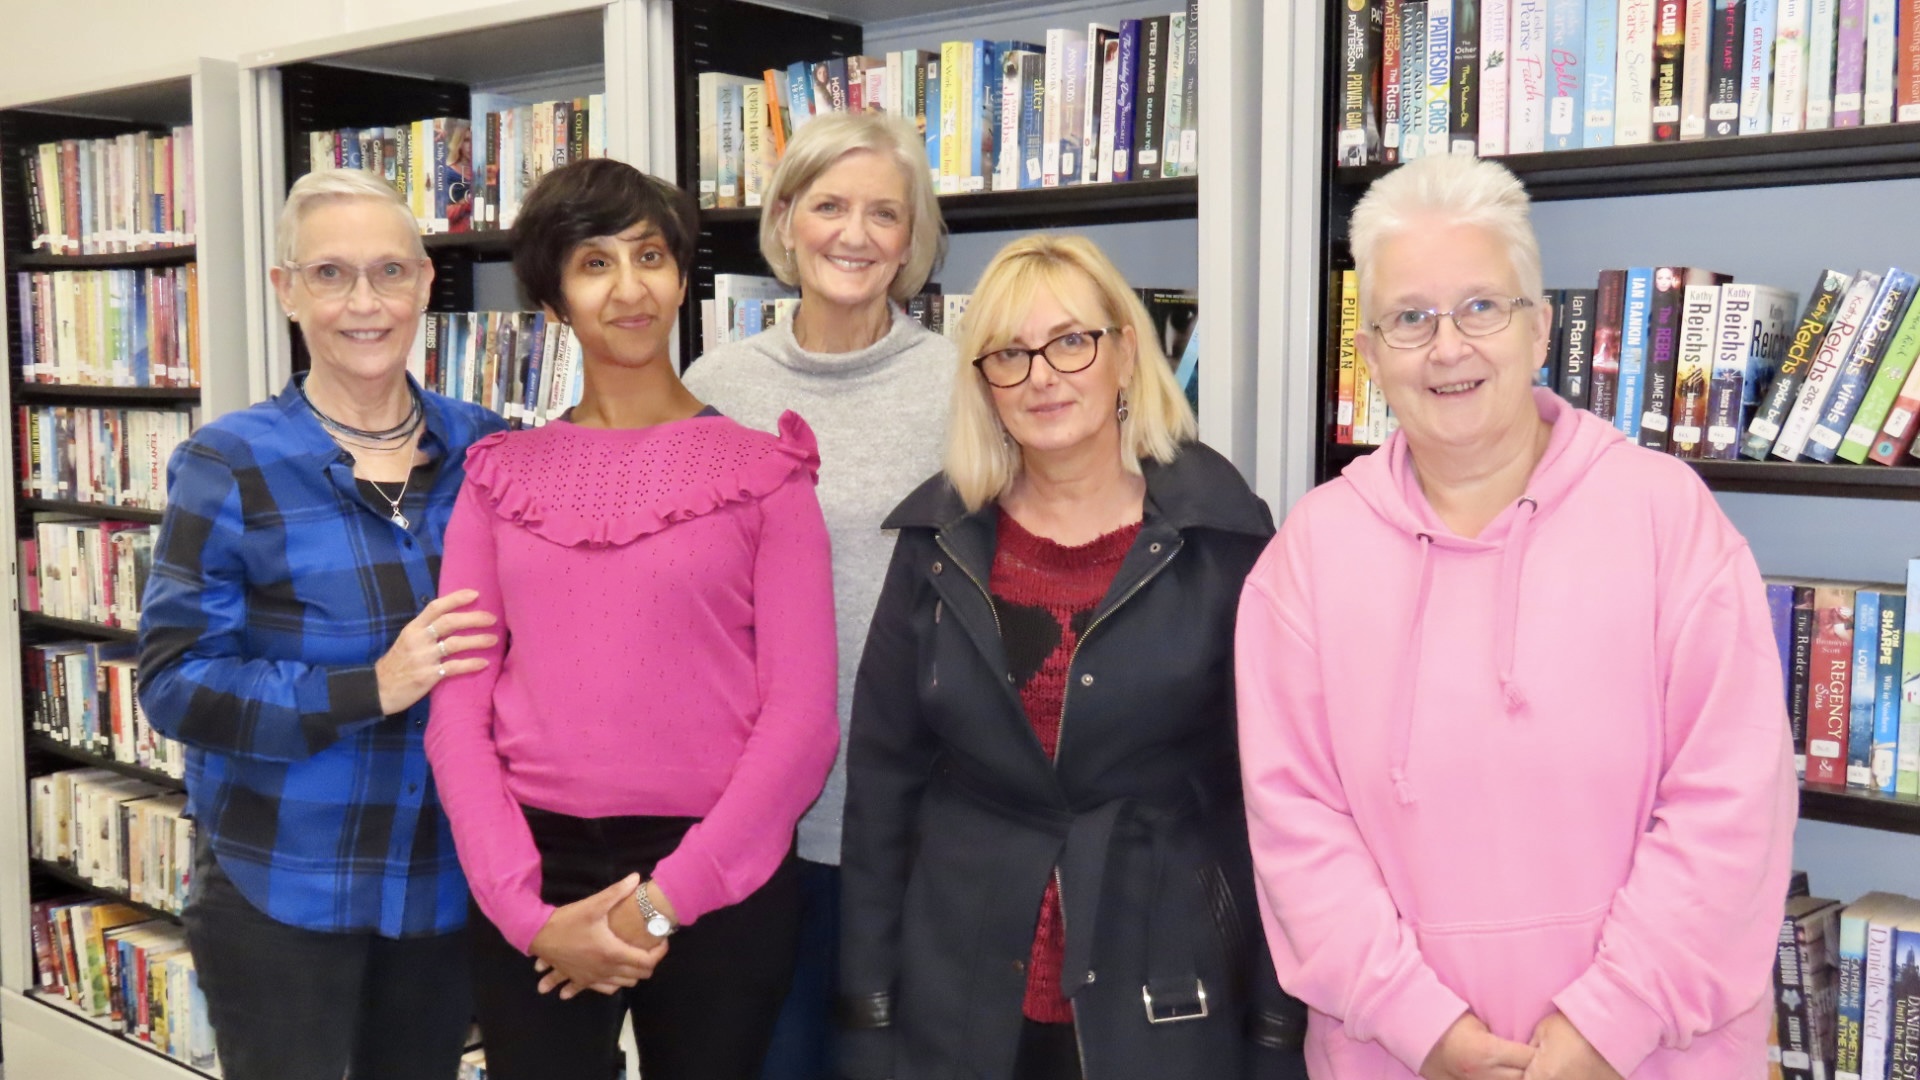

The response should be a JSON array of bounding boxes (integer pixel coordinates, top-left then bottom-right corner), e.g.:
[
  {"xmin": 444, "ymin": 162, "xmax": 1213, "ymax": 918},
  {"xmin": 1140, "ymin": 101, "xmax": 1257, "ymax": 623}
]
[{"xmin": 987, "ymin": 271, "xmax": 1135, "ymax": 459}]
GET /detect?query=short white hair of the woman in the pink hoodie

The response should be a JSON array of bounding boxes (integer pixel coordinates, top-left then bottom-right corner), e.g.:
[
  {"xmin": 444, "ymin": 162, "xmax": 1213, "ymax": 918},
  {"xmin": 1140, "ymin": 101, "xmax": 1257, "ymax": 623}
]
[{"xmin": 1350, "ymin": 154, "xmax": 1542, "ymax": 321}]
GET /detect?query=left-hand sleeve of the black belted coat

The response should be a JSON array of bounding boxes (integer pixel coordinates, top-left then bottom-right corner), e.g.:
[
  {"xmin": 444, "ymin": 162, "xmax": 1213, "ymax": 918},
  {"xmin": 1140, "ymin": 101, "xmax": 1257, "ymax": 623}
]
[{"xmin": 839, "ymin": 532, "xmax": 939, "ymax": 1080}]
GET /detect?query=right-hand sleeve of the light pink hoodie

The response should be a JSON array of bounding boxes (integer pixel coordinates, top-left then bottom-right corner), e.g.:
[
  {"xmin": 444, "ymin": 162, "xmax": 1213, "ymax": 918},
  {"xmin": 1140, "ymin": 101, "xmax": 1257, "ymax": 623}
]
[{"xmin": 1553, "ymin": 534, "xmax": 1799, "ymax": 1076}]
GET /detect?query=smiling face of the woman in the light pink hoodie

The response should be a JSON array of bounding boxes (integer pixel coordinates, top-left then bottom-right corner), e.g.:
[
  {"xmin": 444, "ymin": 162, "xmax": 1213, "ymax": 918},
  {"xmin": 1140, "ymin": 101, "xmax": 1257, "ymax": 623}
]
[{"xmin": 1354, "ymin": 221, "xmax": 1551, "ymax": 450}]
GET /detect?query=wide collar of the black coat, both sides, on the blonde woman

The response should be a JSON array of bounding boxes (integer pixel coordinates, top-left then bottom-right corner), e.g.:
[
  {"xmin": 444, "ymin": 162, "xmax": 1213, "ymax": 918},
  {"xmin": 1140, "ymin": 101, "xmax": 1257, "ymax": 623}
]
[{"xmin": 881, "ymin": 442, "xmax": 1273, "ymax": 540}]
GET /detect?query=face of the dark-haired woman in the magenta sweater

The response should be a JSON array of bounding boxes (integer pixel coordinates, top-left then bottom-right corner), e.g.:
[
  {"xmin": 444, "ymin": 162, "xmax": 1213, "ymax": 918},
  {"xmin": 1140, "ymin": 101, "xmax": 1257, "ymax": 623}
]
[{"xmin": 549, "ymin": 221, "xmax": 685, "ymax": 367}]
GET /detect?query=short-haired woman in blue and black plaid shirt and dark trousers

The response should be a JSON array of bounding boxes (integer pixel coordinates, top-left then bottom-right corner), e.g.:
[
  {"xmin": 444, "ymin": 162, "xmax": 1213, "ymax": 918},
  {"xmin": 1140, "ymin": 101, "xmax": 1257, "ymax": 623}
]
[{"xmin": 140, "ymin": 169, "xmax": 505, "ymax": 1080}]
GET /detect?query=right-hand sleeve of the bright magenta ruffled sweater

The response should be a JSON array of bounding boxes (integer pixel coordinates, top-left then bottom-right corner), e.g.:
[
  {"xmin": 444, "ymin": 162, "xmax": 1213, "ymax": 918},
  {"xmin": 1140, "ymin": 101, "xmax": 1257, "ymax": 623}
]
[{"xmin": 653, "ymin": 469, "xmax": 839, "ymax": 922}]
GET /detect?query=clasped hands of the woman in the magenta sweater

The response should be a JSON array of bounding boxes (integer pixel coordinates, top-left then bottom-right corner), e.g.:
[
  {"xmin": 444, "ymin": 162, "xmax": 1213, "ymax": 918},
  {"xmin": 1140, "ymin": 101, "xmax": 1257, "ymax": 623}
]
[{"xmin": 528, "ymin": 874, "xmax": 666, "ymax": 1001}]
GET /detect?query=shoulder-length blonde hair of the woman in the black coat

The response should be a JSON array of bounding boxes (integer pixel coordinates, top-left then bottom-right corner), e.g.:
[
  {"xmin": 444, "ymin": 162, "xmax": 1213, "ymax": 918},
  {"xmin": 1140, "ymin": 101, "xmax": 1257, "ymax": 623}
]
[{"xmin": 947, "ymin": 233, "xmax": 1198, "ymax": 511}]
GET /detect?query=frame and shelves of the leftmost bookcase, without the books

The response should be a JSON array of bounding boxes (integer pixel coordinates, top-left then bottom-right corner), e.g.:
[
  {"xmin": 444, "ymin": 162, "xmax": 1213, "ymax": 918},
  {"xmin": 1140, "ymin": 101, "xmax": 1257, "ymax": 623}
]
[{"xmin": 0, "ymin": 60, "xmax": 250, "ymax": 1078}]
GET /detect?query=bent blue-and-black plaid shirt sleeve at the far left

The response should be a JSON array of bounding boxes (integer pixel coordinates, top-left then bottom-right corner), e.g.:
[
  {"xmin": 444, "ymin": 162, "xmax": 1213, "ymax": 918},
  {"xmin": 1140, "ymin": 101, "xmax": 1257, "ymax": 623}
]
[{"xmin": 140, "ymin": 438, "xmax": 382, "ymax": 761}]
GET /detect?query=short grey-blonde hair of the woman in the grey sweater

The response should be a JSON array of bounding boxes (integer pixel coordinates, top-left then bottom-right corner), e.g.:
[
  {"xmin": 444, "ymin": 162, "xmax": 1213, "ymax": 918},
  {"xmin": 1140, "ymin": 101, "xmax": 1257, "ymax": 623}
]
[{"xmin": 760, "ymin": 113, "xmax": 947, "ymax": 304}]
